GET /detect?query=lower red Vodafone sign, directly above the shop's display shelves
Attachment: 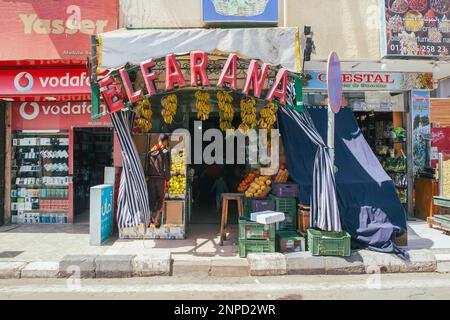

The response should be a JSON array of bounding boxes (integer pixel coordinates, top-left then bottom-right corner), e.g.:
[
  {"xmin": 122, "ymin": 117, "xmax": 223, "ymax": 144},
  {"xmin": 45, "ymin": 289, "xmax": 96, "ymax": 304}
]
[{"xmin": 11, "ymin": 101, "xmax": 111, "ymax": 130}]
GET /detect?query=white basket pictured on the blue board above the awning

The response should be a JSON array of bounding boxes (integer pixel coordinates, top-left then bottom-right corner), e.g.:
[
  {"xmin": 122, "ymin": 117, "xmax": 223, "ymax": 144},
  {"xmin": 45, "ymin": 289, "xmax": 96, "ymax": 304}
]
[{"xmin": 212, "ymin": 0, "xmax": 269, "ymax": 17}]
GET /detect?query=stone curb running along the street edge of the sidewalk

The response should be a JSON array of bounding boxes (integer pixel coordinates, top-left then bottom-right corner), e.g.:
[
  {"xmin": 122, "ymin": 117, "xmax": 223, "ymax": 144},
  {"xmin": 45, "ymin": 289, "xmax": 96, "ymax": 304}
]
[{"xmin": 0, "ymin": 249, "xmax": 442, "ymax": 279}]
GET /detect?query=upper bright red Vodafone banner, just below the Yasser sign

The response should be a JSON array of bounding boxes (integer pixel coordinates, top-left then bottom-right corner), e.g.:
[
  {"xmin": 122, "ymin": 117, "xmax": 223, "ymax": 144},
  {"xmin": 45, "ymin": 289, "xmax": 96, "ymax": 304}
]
[{"xmin": 0, "ymin": 68, "xmax": 91, "ymax": 98}]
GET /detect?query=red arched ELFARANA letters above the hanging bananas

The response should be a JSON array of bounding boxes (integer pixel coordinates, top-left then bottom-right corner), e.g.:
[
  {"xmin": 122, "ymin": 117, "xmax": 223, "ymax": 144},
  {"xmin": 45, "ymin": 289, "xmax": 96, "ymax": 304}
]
[{"xmin": 93, "ymin": 51, "xmax": 289, "ymax": 118}]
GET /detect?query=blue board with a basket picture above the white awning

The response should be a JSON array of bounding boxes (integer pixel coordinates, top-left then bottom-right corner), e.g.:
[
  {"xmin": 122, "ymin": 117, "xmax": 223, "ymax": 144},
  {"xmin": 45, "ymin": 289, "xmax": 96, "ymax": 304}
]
[{"xmin": 202, "ymin": 0, "xmax": 278, "ymax": 24}]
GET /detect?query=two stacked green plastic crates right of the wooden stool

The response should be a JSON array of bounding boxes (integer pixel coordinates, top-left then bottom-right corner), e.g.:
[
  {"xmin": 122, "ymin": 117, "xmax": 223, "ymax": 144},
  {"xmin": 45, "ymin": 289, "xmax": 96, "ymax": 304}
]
[{"xmin": 239, "ymin": 217, "xmax": 275, "ymax": 258}]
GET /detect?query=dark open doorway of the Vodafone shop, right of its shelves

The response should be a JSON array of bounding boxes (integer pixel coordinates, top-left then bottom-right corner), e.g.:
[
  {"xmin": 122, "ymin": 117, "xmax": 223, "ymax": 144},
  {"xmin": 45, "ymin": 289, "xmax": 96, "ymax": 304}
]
[{"xmin": 73, "ymin": 128, "xmax": 114, "ymax": 223}]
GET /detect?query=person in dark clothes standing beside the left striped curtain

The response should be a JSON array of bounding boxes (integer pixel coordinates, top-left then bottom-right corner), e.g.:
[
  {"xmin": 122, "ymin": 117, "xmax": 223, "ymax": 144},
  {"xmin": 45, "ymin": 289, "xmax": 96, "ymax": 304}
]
[{"xmin": 148, "ymin": 134, "xmax": 170, "ymax": 228}]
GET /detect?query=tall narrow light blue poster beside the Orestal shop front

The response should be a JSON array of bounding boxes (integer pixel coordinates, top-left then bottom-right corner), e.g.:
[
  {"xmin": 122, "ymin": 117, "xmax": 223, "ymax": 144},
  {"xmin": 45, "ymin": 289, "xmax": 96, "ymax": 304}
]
[{"xmin": 411, "ymin": 90, "xmax": 431, "ymax": 173}]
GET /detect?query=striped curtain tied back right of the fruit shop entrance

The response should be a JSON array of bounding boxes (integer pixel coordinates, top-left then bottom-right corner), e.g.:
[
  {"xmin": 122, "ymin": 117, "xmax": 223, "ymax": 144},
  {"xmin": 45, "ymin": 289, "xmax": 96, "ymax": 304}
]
[{"xmin": 281, "ymin": 107, "xmax": 342, "ymax": 231}]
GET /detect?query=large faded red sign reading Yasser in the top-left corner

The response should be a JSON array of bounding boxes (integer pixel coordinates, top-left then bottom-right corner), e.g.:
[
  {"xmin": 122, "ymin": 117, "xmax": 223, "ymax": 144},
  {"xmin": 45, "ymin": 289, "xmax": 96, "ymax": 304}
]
[{"xmin": 0, "ymin": 0, "xmax": 118, "ymax": 61}]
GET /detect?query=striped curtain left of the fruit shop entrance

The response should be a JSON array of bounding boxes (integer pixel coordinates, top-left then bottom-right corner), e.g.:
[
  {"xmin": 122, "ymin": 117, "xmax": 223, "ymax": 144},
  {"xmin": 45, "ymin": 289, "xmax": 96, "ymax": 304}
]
[{"xmin": 110, "ymin": 111, "xmax": 150, "ymax": 228}]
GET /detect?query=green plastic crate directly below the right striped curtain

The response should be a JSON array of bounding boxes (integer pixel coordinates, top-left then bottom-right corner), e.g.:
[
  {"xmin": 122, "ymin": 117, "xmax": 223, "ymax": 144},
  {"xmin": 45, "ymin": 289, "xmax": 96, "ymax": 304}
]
[{"xmin": 307, "ymin": 229, "xmax": 351, "ymax": 257}]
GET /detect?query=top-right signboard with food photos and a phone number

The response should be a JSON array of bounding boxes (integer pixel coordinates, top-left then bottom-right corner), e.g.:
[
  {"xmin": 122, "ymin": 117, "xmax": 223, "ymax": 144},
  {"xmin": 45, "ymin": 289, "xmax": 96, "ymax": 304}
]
[{"xmin": 381, "ymin": 0, "xmax": 450, "ymax": 57}]
